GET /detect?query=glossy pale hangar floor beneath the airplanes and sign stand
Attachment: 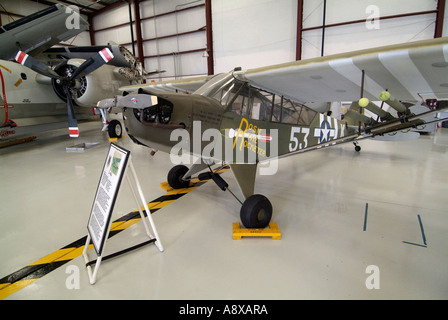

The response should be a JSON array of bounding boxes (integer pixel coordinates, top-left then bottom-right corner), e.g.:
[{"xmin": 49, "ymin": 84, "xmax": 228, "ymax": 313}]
[{"xmin": 0, "ymin": 117, "xmax": 448, "ymax": 300}]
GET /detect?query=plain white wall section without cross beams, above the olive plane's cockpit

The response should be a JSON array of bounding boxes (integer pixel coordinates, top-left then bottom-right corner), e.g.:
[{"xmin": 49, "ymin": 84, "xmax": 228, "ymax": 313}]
[{"xmin": 212, "ymin": 0, "xmax": 297, "ymax": 73}]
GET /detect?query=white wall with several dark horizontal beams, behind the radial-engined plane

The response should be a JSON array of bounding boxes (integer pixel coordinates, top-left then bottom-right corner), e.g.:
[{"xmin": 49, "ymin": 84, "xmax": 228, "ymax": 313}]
[{"xmin": 93, "ymin": 0, "xmax": 207, "ymax": 80}]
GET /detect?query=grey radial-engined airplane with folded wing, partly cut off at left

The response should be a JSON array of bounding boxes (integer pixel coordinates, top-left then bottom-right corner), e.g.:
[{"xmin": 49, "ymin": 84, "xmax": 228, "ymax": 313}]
[{"xmin": 0, "ymin": 4, "xmax": 144, "ymax": 139}]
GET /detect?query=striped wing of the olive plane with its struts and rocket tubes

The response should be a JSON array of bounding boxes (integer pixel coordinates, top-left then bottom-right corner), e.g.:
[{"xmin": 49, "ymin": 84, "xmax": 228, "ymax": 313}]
[{"xmin": 239, "ymin": 38, "xmax": 448, "ymax": 156}]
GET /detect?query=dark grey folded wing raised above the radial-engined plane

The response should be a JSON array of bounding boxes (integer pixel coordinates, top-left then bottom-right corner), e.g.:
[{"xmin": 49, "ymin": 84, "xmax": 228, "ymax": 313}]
[{"xmin": 0, "ymin": 4, "xmax": 89, "ymax": 60}]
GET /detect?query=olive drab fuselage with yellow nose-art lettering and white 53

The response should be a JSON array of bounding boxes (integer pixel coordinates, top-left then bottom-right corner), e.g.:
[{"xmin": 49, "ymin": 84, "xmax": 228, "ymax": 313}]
[{"xmin": 123, "ymin": 74, "xmax": 350, "ymax": 163}]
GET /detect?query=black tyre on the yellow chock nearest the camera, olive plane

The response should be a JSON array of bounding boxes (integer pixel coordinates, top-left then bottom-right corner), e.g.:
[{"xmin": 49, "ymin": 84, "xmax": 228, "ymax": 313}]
[{"xmin": 240, "ymin": 194, "xmax": 272, "ymax": 228}]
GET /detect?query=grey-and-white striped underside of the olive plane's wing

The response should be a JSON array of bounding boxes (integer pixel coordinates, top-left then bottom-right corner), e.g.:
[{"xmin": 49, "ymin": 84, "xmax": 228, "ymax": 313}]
[{"xmin": 244, "ymin": 38, "xmax": 448, "ymax": 103}]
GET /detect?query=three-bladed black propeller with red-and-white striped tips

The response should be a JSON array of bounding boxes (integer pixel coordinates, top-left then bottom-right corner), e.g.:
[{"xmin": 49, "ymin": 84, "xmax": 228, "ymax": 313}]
[{"xmin": 15, "ymin": 48, "xmax": 114, "ymax": 138}]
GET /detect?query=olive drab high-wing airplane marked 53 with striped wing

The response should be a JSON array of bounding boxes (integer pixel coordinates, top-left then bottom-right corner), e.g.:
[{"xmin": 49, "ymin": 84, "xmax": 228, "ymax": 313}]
[{"xmin": 99, "ymin": 38, "xmax": 448, "ymax": 228}]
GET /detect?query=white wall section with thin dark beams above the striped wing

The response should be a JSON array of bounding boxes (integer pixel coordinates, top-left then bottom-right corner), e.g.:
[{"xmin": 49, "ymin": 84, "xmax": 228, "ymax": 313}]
[{"xmin": 302, "ymin": 0, "xmax": 437, "ymax": 59}]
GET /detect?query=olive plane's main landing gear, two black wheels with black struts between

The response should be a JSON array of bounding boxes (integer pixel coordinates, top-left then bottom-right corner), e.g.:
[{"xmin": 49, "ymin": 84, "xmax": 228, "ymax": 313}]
[{"xmin": 168, "ymin": 165, "xmax": 272, "ymax": 229}]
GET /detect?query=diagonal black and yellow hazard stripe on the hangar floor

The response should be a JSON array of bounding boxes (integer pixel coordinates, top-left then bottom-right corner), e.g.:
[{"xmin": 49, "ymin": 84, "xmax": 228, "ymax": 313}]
[{"xmin": 0, "ymin": 168, "xmax": 227, "ymax": 300}]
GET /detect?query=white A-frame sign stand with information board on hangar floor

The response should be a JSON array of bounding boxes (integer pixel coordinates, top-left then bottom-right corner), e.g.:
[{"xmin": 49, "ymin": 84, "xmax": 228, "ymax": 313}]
[{"xmin": 82, "ymin": 143, "xmax": 163, "ymax": 284}]
